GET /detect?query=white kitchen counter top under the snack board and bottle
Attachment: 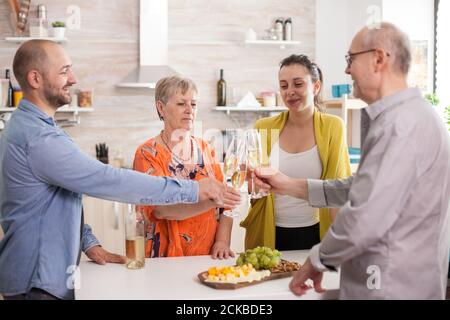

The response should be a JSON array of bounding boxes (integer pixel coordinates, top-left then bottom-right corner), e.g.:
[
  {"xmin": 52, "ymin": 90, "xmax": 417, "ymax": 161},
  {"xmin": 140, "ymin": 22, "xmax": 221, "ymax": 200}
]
[{"xmin": 75, "ymin": 250, "xmax": 339, "ymax": 300}]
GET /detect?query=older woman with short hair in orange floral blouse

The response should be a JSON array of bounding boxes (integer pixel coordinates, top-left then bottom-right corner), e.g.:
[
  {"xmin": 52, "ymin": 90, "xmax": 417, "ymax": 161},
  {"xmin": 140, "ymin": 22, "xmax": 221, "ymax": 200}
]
[{"xmin": 134, "ymin": 76, "xmax": 237, "ymax": 259}]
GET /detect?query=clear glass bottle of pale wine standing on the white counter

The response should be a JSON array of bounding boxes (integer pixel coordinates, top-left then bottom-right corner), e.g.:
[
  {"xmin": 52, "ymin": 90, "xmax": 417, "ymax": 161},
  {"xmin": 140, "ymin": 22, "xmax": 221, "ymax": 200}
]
[{"xmin": 125, "ymin": 204, "xmax": 145, "ymax": 269}]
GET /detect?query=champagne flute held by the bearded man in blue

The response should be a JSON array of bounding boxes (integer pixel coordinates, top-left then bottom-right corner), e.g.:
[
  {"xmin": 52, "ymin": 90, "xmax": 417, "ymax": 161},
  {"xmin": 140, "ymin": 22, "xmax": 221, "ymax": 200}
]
[{"xmin": 223, "ymin": 136, "xmax": 247, "ymax": 218}]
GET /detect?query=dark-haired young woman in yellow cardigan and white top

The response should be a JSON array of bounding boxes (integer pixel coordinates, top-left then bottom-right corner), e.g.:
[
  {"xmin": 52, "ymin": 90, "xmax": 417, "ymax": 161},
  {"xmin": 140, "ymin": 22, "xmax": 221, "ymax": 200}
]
[{"xmin": 241, "ymin": 55, "xmax": 351, "ymax": 250}]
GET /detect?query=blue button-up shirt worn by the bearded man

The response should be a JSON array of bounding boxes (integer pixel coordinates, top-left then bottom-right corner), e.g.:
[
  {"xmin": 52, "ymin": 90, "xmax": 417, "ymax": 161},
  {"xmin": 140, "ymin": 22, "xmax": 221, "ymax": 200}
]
[{"xmin": 0, "ymin": 99, "xmax": 198, "ymax": 299}]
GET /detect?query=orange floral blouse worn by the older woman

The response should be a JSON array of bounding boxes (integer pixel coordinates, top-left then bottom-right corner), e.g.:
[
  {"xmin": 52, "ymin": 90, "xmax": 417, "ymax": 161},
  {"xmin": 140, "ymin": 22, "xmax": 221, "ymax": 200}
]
[{"xmin": 133, "ymin": 137, "xmax": 223, "ymax": 258}]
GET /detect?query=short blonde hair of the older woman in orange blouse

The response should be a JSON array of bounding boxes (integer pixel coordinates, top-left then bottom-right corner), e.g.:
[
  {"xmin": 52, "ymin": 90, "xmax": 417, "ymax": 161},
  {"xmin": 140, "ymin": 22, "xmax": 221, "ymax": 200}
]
[{"xmin": 155, "ymin": 76, "xmax": 198, "ymax": 120}]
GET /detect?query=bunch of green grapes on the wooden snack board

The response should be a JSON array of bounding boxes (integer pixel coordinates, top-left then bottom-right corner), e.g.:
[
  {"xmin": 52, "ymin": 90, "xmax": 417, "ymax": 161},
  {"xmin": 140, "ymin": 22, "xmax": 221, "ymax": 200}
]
[{"xmin": 236, "ymin": 247, "xmax": 281, "ymax": 270}]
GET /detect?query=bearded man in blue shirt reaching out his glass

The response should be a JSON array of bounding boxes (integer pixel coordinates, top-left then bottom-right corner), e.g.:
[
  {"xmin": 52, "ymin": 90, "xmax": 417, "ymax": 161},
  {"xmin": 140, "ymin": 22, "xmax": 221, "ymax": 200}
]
[{"xmin": 0, "ymin": 40, "xmax": 240, "ymax": 299}]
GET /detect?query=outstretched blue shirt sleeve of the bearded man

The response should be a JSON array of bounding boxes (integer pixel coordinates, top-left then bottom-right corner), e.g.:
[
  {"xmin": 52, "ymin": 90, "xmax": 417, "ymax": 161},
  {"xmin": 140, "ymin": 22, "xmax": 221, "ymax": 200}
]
[{"xmin": 28, "ymin": 132, "xmax": 199, "ymax": 205}]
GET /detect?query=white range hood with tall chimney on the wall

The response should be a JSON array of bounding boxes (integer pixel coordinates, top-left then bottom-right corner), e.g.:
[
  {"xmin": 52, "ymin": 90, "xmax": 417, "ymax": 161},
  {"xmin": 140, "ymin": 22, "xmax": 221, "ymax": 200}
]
[{"xmin": 117, "ymin": 0, "xmax": 178, "ymax": 89}]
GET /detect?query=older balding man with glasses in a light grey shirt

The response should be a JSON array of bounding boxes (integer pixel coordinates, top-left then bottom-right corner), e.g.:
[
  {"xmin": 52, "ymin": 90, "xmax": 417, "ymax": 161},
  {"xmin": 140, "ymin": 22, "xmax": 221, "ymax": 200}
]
[{"xmin": 257, "ymin": 23, "xmax": 450, "ymax": 299}]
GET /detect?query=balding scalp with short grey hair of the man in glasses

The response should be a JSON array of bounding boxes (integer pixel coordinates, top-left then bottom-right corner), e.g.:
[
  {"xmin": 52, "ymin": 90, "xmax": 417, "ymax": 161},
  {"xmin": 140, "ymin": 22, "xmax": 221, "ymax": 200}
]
[{"xmin": 357, "ymin": 22, "xmax": 411, "ymax": 76}]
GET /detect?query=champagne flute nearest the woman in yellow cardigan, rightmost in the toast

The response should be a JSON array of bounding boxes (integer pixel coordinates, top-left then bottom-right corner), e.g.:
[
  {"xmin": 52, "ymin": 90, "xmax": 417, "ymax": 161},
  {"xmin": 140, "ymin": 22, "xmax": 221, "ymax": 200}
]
[{"xmin": 246, "ymin": 129, "xmax": 267, "ymax": 199}]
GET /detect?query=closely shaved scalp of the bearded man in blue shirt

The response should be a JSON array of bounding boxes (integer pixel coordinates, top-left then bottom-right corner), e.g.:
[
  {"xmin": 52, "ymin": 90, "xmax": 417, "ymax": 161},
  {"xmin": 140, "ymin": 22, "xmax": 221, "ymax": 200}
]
[{"xmin": 13, "ymin": 40, "xmax": 59, "ymax": 91}]
